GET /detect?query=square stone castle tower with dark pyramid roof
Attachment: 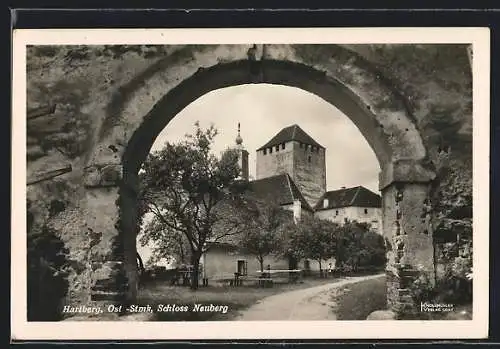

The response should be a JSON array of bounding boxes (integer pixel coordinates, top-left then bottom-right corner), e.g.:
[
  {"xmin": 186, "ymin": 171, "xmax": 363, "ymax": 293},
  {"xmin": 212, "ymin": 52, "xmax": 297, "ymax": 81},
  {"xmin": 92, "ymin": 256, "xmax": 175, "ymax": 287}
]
[{"xmin": 257, "ymin": 125, "xmax": 326, "ymax": 207}]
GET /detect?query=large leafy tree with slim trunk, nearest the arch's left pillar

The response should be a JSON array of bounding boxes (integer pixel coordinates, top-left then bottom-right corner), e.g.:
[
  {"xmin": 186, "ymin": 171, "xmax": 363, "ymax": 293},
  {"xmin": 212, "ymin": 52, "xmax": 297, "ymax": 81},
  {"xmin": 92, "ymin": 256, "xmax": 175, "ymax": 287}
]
[{"xmin": 141, "ymin": 122, "xmax": 240, "ymax": 289}]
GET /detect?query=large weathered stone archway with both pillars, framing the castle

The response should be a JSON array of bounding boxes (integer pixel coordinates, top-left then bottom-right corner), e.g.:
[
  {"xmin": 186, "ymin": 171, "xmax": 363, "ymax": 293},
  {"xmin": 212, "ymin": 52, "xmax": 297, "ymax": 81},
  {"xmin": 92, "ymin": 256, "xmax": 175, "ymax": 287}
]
[{"xmin": 84, "ymin": 45, "xmax": 434, "ymax": 311}]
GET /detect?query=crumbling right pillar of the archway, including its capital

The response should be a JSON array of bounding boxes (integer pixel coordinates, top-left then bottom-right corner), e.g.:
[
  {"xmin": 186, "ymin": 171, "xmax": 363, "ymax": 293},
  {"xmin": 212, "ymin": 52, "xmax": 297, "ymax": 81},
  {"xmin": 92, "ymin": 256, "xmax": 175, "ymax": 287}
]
[{"xmin": 381, "ymin": 162, "xmax": 434, "ymax": 318}]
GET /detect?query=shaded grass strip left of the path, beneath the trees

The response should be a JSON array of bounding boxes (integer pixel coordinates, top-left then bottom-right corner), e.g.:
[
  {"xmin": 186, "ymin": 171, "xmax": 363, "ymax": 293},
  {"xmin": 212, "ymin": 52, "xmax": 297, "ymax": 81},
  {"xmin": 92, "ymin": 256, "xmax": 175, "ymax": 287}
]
[{"xmin": 137, "ymin": 278, "xmax": 348, "ymax": 321}]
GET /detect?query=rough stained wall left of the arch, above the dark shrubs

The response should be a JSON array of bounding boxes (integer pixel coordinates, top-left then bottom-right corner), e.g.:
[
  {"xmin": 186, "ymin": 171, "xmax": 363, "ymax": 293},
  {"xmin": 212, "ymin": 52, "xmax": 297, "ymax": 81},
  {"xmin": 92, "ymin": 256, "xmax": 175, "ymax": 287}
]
[{"xmin": 26, "ymin": 46, "xmax": 182, "ymax": 303}]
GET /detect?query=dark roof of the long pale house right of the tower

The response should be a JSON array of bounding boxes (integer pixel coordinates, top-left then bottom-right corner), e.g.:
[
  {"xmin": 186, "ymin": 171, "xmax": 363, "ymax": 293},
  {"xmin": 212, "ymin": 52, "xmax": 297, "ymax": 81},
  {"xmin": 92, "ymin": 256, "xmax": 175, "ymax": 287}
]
[{"xmin": 314, "ymin": 186, "xmax": 382, "ymax": 211}]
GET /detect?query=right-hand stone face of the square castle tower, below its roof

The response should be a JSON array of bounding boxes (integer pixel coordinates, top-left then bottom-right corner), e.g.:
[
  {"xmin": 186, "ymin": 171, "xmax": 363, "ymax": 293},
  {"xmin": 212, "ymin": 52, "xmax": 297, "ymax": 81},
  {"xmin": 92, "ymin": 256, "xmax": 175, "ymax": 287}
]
[{"xmin": 290, "ymin": 142, "xmax": 326, "ymax": 207}]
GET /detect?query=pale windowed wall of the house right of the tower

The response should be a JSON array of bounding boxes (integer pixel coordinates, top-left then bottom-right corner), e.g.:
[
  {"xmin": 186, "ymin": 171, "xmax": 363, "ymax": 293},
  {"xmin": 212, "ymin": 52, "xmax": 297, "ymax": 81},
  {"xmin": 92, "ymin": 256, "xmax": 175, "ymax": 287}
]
[{"xmin": 315, "ymin": 206, "xmax": 382, "ymax": 234}]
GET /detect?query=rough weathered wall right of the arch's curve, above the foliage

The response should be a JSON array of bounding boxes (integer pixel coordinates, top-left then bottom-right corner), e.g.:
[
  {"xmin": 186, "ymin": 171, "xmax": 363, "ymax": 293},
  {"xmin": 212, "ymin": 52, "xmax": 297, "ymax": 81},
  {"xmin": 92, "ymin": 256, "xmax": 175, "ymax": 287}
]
[{"xmin": 347, "ymin": 44, "xmax": 472, "ymax": 190}]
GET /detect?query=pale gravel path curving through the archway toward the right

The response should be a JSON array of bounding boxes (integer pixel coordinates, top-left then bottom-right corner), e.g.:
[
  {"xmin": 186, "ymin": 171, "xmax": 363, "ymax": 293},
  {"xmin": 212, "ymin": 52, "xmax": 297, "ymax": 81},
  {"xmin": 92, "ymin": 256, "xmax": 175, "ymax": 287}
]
[{"xmin": 234, "ymin": 274, "xmax": 385, "ymax": 321}]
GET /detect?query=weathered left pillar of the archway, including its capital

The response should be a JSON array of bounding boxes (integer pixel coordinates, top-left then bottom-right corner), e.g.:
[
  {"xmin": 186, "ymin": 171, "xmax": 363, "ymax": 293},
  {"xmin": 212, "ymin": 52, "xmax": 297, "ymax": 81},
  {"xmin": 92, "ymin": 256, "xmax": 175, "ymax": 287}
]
[{"xmin": 84, "ymin": 163, "xmax": 137, "ymax": 304}]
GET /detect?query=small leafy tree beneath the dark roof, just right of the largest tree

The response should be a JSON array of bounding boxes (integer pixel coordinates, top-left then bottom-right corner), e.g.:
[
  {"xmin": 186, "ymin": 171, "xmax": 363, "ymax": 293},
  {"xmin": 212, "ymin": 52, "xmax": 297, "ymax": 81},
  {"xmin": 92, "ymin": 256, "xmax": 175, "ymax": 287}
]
[{"xmin": 239, "ymin": 194, "xmax": 291, "ymax": 272}]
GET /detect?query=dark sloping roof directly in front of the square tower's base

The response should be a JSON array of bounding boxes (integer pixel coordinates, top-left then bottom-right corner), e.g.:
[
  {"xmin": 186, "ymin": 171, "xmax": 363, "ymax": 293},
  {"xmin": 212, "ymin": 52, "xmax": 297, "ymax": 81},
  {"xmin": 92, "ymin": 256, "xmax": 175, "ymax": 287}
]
[{"xmin": 248, "ymin": 173, "xmax": 312, "ymax": 212}]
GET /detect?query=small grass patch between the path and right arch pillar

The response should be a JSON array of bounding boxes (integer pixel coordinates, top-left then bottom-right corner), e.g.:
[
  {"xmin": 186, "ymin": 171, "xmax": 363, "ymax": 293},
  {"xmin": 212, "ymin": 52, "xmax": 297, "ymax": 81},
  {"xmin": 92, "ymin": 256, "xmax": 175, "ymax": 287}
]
[{"xmin": 332, "ymin": 277, "xmax": 387, "ymax": 320}]
